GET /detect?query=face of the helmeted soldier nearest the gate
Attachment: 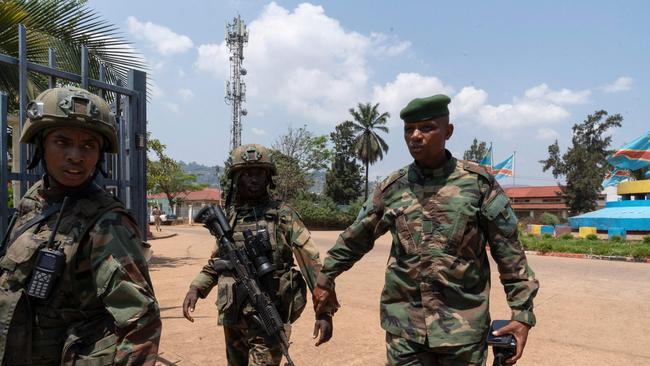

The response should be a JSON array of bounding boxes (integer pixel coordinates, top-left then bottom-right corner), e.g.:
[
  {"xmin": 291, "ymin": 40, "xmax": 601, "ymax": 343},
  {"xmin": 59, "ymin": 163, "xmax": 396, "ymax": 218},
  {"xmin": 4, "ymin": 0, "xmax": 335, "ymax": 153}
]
[{"xmin": 43, "ymin": 127, "xmax": 101, "ymax": 188}]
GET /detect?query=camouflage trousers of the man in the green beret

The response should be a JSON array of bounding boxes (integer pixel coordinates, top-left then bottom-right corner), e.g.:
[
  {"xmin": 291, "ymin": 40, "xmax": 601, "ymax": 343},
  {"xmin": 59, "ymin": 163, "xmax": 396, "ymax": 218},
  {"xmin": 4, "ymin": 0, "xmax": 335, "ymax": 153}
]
[{"xmin": 386, "ymin": 332, "xmax": 487, "ymax": 366}]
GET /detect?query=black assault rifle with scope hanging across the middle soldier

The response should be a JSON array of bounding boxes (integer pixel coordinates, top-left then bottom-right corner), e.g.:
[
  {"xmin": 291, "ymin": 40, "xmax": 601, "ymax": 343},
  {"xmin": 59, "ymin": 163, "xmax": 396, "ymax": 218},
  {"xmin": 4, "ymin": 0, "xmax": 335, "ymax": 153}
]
[{"xmin": 194, "ymin": 205, "xmax": 295, "ymax": 366}]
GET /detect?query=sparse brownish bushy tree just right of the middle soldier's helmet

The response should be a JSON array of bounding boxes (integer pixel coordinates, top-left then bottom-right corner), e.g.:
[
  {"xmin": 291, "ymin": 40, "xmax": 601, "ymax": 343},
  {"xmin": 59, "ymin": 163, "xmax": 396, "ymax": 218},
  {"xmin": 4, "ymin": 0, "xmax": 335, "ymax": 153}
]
[{"xmin": 273, "ymin": 150, "xmax": 311, "ymax": 202}]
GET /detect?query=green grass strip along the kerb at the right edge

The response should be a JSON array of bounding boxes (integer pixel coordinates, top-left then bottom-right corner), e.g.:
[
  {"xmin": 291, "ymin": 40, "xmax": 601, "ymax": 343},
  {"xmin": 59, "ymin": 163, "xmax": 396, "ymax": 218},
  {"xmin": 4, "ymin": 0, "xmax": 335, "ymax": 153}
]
[{"xmin": 520, "ymin": 235, "xmax": 650, "ymax": 258}]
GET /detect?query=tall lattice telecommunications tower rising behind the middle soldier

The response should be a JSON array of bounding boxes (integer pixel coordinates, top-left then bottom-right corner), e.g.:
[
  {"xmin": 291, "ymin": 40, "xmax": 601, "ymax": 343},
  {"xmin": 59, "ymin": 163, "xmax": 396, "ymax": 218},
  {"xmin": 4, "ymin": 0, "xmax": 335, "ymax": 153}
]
[{"xmin": 225, "ymin": 15, "xmax": 248, "ymax": 150}]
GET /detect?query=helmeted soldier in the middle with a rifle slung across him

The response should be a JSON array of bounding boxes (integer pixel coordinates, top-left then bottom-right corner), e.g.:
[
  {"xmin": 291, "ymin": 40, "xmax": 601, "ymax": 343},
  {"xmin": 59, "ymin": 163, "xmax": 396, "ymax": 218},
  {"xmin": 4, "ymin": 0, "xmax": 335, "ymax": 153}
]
[{"xmin": 183, "ymin": 144, "xmax": 335, "ymax": 366}]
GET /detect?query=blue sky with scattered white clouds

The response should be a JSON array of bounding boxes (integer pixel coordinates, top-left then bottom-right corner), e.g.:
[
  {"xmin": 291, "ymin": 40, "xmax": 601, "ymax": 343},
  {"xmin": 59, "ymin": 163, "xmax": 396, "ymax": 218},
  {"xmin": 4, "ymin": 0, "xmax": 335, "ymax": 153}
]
[{"xmin": 88, "ymin": 0, "xmax": 650, "ymax": 185}]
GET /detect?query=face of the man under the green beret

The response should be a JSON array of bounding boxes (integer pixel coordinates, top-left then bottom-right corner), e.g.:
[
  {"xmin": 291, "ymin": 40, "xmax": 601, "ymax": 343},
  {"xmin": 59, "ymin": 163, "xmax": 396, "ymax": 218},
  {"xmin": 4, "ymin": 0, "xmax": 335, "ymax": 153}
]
[{"xmin": 404, "ymin": 117, "xmax": 454, "ymax": 168}]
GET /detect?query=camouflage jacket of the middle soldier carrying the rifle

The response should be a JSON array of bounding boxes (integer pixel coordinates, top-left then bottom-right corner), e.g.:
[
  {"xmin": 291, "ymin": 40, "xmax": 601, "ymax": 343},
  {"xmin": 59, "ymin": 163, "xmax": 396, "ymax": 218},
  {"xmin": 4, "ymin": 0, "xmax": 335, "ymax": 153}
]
[{"xmin": 191, "ymin": 200, "xmax": 321, "ymax": 325}]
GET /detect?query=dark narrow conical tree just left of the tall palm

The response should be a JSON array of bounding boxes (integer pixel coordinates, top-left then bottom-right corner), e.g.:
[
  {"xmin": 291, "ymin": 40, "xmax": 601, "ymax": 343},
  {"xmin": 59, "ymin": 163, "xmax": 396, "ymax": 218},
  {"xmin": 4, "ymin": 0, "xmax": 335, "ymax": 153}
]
[{"xmin": 325, "ymin": 121, "xmax": 363, "ymax": 204}]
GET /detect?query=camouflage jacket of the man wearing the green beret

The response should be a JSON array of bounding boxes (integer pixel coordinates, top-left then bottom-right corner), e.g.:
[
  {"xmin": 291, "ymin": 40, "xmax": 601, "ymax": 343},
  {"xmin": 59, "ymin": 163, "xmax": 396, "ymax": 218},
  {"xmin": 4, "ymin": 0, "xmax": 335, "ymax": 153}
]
[{"xmin": 318, "ymin": 153, "xmax": 539, "ymax": 347}]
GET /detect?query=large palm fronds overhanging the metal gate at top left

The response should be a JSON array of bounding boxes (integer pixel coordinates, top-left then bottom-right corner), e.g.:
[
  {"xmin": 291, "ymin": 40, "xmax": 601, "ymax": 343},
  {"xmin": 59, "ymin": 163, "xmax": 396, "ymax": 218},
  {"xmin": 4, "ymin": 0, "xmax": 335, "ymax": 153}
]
[{"xmin": 0, "ymin": 0, "xmax": 147, "ymax": 108}]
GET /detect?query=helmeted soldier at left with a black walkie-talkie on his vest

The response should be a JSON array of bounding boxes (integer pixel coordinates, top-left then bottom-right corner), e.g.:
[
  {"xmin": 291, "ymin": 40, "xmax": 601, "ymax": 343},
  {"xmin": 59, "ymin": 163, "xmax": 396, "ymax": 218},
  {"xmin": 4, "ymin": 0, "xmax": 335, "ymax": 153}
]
[{"xmin": 0, "ymin": 87, "xmax": 161, "ymax": 365}]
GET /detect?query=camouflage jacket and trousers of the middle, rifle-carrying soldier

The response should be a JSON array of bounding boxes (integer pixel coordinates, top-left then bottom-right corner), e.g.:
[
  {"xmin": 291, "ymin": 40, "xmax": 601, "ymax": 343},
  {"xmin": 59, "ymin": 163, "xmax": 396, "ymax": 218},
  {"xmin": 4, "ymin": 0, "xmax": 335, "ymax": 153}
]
[{"xmin": 191, "ymin": 145, "xmax": 321, "ymax": 366}]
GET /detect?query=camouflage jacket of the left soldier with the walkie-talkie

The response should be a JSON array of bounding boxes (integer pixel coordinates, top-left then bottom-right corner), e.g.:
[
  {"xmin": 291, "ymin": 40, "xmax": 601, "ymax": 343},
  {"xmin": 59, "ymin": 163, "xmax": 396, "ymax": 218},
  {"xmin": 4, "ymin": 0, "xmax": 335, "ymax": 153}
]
[{"xmin": 0, "ymin": 181, "xmax": 161, "ymax": 365}]
